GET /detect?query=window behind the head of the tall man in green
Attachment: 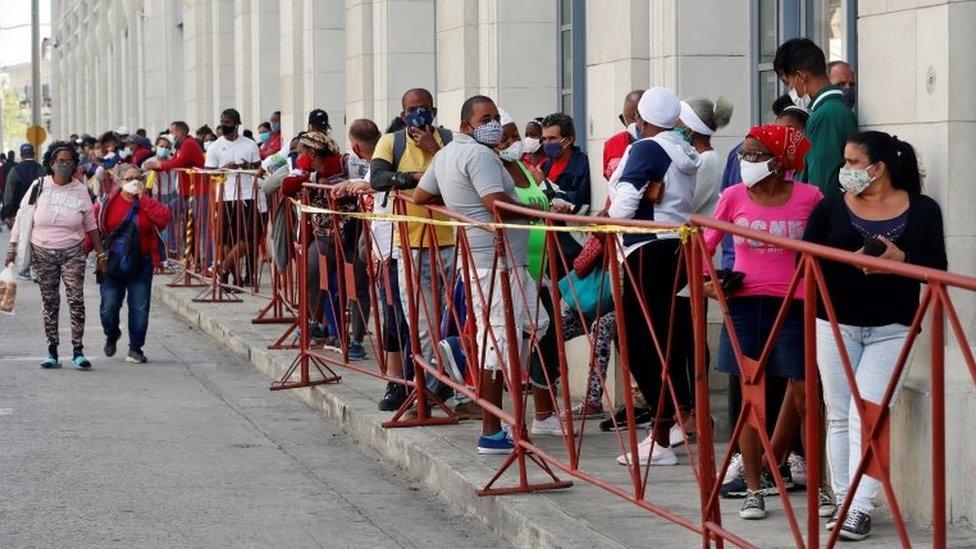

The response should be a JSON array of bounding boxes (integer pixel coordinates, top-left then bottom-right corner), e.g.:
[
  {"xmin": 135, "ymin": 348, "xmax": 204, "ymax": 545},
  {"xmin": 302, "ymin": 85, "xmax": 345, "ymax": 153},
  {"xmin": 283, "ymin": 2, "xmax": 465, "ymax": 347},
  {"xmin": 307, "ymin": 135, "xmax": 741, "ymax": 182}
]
[{"xmin": 751, "ymin": 0, "xmax": 857, "ymax": 123}]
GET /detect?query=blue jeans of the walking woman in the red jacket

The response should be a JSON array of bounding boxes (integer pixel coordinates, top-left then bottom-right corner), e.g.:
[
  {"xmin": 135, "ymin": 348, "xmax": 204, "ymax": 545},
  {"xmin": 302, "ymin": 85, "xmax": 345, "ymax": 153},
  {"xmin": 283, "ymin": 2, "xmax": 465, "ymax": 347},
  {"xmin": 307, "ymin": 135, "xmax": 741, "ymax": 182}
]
[{"xmin": 98, "ymin": 257, "xmax": 153, "ymax": 351}]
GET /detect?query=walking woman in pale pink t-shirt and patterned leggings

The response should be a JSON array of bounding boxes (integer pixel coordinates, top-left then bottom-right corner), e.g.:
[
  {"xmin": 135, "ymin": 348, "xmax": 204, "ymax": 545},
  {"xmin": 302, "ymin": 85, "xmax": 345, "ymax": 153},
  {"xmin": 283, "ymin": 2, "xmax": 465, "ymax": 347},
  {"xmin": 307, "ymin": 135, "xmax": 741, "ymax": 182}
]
[{"xmin": 5, "ymin": 141, "xmax": 108, "ymax": 370}]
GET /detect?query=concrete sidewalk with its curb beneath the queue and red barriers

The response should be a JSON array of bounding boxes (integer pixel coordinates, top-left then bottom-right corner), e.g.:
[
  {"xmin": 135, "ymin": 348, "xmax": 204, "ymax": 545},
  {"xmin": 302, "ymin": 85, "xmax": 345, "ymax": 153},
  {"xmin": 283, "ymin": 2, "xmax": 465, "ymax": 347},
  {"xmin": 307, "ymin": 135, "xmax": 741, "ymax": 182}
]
[{"xmin": 153, "ymin": 277, "xmax": 976, "ymax": 547}]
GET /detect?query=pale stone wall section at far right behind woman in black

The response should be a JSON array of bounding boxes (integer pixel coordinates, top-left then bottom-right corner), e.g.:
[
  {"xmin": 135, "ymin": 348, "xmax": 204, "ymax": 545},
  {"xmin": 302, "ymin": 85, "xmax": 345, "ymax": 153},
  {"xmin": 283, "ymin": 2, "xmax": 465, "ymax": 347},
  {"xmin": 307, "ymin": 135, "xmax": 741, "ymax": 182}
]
[{"xmin": 857, "ymin": 0, "xmax": 976, "ymax": 524}]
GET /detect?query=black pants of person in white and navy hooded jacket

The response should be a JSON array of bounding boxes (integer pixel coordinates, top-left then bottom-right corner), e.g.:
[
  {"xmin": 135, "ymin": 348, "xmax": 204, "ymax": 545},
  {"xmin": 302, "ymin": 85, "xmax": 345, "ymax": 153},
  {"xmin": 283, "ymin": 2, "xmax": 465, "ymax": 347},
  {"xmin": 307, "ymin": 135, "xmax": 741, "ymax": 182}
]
[{"xmin": 622, "ymin": 238, "xmax": 694, "ymax": 418}]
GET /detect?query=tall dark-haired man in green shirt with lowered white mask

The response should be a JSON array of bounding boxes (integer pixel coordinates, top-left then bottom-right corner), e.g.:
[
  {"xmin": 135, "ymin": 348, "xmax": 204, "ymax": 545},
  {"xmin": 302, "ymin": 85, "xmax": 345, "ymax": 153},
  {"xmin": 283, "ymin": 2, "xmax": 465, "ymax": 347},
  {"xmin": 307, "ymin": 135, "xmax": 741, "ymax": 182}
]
[{"xmin": 773, "ymin": 38, "xmax": 857, "ymax": 196}]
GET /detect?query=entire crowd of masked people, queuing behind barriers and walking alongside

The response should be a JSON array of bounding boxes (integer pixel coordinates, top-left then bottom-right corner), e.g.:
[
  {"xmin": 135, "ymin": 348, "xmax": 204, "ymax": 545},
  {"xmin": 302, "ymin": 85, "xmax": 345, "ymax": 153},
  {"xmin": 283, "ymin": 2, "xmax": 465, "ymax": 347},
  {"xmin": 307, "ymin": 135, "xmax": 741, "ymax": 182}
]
[{"xmin": 2, "ymin": 39, "xmax": 947, "ymax": 540}]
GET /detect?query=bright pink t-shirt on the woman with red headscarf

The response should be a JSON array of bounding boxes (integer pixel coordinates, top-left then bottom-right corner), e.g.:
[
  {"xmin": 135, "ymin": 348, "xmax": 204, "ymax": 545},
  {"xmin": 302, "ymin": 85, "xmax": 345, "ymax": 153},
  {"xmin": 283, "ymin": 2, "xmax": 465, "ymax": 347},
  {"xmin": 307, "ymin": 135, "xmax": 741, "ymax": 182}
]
[{"xmin": 705, "ymin": 182, "xmax": 823, "ymax": 299}]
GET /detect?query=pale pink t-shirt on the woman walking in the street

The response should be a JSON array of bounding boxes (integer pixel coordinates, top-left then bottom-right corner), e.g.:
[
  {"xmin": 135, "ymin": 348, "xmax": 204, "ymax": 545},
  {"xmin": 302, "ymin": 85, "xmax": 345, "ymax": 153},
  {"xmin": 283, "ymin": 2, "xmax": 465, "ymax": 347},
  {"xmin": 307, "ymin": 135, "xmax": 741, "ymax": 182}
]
[{"xmin": 11, "ymin": 176, "xmax": 98, "ymax": 250}]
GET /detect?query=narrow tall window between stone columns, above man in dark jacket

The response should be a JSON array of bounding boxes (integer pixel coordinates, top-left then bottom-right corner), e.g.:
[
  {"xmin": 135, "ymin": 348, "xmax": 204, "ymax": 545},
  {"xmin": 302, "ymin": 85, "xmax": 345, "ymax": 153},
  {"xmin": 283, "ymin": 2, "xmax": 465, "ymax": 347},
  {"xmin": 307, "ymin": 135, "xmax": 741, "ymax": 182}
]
[{"xmin": 558, "ymin": 0, "xmax": 586, "ymax": 149}]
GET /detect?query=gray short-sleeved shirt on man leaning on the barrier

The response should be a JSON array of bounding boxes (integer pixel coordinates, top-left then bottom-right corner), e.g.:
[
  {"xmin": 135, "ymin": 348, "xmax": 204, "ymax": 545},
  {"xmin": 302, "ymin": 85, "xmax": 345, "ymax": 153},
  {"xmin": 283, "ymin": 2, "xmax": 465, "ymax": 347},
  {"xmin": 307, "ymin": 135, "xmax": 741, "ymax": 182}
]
[{"xmin": 418, "ymin": 133, "xmax": 529, "ymax": 269}]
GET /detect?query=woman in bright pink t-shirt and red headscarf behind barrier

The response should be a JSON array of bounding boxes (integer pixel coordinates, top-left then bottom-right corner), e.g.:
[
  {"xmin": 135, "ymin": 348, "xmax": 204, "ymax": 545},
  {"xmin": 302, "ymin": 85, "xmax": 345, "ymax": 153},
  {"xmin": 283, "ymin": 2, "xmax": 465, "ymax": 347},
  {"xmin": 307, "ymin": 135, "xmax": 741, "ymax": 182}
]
[{"xmin": 705, "ymin": 124, "xmax": 823, "ymax": 519}]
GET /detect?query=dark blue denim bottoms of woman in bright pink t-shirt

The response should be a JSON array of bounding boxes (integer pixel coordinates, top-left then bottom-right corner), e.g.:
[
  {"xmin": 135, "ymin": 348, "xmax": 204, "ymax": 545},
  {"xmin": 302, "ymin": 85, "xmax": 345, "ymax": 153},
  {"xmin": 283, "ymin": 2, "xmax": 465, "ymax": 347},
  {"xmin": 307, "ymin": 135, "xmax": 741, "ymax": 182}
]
[{"xmin": 716, "ymin": 296, "xmax": 803, "ymax": 380}]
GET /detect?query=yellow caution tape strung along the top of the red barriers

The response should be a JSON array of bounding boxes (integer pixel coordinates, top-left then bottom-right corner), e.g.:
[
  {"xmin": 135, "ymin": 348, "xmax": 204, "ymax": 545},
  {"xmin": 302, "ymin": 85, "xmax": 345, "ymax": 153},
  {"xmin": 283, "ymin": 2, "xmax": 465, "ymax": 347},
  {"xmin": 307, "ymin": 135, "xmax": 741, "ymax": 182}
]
[{"xmin": 291, "ymin": 198, "xmax": 698, "ymax": 238}]
